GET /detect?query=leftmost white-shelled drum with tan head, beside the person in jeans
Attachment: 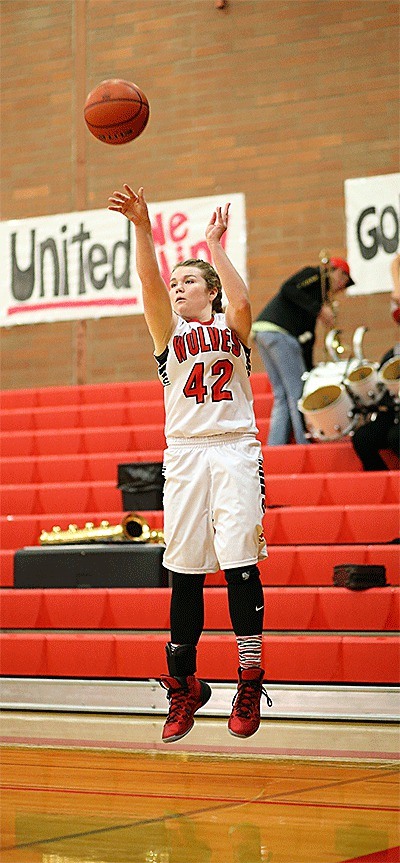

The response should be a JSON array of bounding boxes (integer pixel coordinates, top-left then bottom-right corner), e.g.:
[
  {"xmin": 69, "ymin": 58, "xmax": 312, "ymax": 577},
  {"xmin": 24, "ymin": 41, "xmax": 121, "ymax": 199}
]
[{"xmin": 298, "ymin": 384, "xmax": 357, "ymax": 441}]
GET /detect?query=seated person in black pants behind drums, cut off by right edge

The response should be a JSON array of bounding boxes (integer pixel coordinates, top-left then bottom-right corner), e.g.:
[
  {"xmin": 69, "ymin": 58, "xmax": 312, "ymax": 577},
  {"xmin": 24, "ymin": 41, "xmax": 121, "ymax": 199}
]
[{"xmin": 351, "ymin": 255, "xmax": 400, "ymax": 470}]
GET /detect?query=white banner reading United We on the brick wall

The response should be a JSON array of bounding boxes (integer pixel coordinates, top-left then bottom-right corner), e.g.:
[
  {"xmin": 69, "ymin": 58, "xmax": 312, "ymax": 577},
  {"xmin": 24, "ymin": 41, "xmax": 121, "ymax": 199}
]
[{"xmin": 0, "ymin": 193, "xmax": 247, "ymax": 326}]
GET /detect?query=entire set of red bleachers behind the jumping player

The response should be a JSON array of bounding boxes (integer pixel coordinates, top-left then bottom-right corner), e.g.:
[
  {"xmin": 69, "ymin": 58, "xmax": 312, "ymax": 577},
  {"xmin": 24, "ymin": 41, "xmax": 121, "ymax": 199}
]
[{"xmin": 0, "ymin": 374, "xmax": 400, "ymax": 685}]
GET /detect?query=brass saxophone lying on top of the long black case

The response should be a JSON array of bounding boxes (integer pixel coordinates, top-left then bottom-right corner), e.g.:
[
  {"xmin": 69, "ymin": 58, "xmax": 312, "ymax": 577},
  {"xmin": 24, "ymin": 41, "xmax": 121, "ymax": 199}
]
[{"xmin": 39, "ymin": 512, "xmax": 164, "ymax": 545}]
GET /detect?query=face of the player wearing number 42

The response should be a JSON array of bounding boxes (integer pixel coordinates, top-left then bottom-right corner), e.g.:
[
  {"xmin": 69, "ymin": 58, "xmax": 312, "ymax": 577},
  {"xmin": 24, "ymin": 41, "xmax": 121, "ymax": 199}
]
[{"xmin": 169, "ymin": 267, "xmax": 216, "ymax": 321}]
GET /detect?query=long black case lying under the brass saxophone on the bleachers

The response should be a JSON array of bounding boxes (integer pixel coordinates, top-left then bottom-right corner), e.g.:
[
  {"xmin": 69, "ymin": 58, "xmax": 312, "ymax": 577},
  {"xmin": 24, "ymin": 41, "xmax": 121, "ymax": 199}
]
[{"xmin": 14, "ymin": 542, "xmax": 168, "ymax": 588}]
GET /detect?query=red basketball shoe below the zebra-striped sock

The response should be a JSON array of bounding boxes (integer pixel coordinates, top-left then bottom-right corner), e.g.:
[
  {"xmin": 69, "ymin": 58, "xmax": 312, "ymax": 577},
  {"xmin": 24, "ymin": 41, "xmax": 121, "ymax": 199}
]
[{"xmin": 228, "ymin": 668, "xmax": 272, "ymax": 737}]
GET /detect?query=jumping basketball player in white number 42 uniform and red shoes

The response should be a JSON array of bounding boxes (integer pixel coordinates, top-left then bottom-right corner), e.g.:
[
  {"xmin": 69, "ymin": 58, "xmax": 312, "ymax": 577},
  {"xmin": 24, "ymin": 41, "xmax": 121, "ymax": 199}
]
[{"xmin": 109, "ymin": 185, "xmax": 271, "ymax": 743}]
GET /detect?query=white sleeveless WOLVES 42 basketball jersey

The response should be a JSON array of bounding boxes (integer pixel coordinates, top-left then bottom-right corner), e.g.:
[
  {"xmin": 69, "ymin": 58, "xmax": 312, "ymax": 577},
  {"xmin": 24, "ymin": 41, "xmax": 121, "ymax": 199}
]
[{"xmin": 156, "ymin": 314, "xmax": 258, "ymax": 441}]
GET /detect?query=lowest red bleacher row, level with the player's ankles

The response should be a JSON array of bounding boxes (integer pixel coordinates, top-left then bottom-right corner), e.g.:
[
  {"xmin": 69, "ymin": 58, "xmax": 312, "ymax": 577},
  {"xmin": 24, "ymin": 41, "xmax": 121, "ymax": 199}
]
[{"xmin": 1, "ymin": 632, "xmax": 399, "ymax": 685}]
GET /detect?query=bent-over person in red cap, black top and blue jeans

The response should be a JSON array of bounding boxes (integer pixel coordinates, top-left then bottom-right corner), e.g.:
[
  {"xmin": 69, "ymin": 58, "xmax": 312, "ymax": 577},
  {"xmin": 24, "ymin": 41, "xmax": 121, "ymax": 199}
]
[{"xmin": 252, "ymin": 257, "xmax": 354, "ymax": 446}]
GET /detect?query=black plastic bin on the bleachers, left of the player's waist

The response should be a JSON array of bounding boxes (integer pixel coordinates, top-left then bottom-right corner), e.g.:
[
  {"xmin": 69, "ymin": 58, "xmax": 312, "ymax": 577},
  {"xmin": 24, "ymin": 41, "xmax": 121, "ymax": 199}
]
[{"xmin": 117, "ymin": 461, "xmax": 164, "ymax": 512}]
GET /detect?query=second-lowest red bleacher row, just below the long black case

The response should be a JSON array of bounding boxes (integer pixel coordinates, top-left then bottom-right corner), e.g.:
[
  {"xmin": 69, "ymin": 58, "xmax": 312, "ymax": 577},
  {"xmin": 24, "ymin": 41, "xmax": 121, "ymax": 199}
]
[{"xmin": 1, "ymin": 587, "xmax": 400, "ymax": 632}]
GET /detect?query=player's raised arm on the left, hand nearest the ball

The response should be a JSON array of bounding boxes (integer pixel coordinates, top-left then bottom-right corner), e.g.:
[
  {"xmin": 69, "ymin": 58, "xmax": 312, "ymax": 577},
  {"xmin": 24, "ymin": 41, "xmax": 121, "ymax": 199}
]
[{"xmin": 108, "ymin": 183, "xmax": 174, "ymax": 354}]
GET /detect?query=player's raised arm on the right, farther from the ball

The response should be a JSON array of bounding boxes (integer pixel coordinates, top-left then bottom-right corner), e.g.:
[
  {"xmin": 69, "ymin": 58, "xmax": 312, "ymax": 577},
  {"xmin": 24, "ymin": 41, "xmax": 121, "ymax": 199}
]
[{"xmin": 206, "ymin": 204, "xmax": 251, "ymax": 344}]
